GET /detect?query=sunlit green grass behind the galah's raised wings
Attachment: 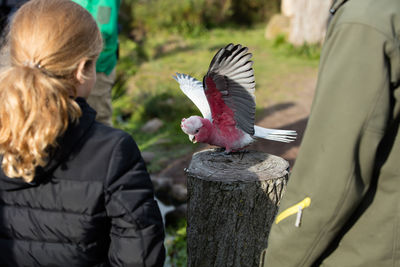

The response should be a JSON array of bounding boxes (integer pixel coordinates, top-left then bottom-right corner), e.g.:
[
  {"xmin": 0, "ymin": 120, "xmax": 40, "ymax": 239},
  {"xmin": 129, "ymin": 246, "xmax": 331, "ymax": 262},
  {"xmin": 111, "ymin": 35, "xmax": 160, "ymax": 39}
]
[{"xmin": 113, "ymin": 26, "xmax": 318, "ymax": 172}]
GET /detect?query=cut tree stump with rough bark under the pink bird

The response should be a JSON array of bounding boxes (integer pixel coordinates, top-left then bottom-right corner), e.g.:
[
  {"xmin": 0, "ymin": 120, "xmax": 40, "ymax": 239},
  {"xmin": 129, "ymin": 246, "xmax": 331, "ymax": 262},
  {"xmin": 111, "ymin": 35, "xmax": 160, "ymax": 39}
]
[{"xmin": 186, "ymin": 149, "xmax": 289, "ymax": 267}]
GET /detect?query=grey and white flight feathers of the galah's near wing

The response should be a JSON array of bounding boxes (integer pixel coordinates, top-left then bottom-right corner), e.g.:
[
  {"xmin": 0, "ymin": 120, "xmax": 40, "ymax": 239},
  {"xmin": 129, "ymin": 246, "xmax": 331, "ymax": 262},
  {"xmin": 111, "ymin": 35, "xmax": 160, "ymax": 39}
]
[{"xmin": 203, "ymin": 44, "xmax": 256, "ymax": 135}]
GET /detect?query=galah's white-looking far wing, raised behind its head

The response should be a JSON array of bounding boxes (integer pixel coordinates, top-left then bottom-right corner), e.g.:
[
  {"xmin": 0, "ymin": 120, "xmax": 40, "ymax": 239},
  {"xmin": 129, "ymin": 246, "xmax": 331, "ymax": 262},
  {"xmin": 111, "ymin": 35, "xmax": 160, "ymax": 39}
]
[{"xmin": 172, "ymin": 73, "xmax": 212, "ymax": 121}]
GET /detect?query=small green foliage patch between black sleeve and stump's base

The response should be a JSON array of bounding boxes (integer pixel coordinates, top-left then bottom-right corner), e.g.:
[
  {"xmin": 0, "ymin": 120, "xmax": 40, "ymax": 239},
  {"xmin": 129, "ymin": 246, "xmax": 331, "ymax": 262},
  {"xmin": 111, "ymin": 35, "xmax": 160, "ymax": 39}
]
[{"xmin": 165, "ymin": 220, "xmax": 187, "ymax": 267}]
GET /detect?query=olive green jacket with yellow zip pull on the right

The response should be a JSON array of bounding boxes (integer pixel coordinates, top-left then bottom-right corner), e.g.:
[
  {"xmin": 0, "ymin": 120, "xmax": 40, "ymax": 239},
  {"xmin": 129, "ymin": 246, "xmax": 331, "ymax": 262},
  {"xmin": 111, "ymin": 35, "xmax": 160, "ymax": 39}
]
[{"xmin": 260, "ymin": 0, "xmax": 400, "ymax": 267}]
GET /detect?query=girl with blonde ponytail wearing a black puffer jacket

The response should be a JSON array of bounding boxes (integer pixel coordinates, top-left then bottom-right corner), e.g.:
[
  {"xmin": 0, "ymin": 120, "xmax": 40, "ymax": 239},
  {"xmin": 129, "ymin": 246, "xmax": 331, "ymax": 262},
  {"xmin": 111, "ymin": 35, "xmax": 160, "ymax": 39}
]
[{"xmin": 0, "ymin": 0, "xmax": 165, "ymax": 266}]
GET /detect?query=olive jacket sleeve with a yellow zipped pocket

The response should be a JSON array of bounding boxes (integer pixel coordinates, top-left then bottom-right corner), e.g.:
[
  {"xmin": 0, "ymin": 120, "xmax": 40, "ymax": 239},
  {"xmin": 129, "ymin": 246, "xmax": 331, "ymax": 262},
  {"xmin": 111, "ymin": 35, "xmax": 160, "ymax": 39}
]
[{"xmin": 262, "ymin": 23, "xmax": 393, "ymax": 267}]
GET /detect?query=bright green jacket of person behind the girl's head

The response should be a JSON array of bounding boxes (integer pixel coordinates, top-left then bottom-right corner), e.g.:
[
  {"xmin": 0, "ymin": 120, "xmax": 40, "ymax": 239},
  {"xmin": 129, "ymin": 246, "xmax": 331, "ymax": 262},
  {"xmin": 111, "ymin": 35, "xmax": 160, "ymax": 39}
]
[{"xmin": 72, "ymin": 0, "xmax": 120, "ymax": 75}]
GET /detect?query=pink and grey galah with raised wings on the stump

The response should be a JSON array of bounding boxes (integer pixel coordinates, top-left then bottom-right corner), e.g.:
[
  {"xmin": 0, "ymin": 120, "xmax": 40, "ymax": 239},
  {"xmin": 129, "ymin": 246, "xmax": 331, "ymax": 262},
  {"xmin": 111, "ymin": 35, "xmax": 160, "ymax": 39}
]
[{"xmin": 173, "ymin": 44, "xmax": 297, "ymax": 153}]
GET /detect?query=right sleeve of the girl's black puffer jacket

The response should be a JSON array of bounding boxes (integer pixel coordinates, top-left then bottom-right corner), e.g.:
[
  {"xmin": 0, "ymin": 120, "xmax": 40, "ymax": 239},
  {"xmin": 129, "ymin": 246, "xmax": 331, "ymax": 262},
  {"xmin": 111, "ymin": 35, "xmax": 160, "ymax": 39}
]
[{"xmin": 105, "ymin": 134, "xmax": 165, "ymax": 267}]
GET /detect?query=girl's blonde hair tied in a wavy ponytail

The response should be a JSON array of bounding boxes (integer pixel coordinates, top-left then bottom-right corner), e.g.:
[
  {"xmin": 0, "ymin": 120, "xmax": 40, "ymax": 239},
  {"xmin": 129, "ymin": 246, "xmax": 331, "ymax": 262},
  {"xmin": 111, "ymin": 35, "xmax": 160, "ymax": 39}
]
[{"xmin": 0, "ymin": 0, "xmax": 102, "ymax": 182}]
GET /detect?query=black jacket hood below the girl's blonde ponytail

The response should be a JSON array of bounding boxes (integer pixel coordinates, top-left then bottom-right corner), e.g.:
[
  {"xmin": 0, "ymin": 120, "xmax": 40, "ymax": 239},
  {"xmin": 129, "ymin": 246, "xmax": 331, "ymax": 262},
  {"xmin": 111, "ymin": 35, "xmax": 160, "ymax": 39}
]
[{"xmin": 0, "ymin": 97, "xmax": 96, "ymax": 191}]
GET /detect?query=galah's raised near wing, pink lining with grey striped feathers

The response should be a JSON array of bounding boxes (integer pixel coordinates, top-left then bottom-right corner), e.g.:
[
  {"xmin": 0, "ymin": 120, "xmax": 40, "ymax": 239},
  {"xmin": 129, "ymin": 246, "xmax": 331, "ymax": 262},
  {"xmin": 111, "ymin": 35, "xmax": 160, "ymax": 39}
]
[{"xmin": 203, "ymin": 44, "xmax": 256, "ymax": 135}]
